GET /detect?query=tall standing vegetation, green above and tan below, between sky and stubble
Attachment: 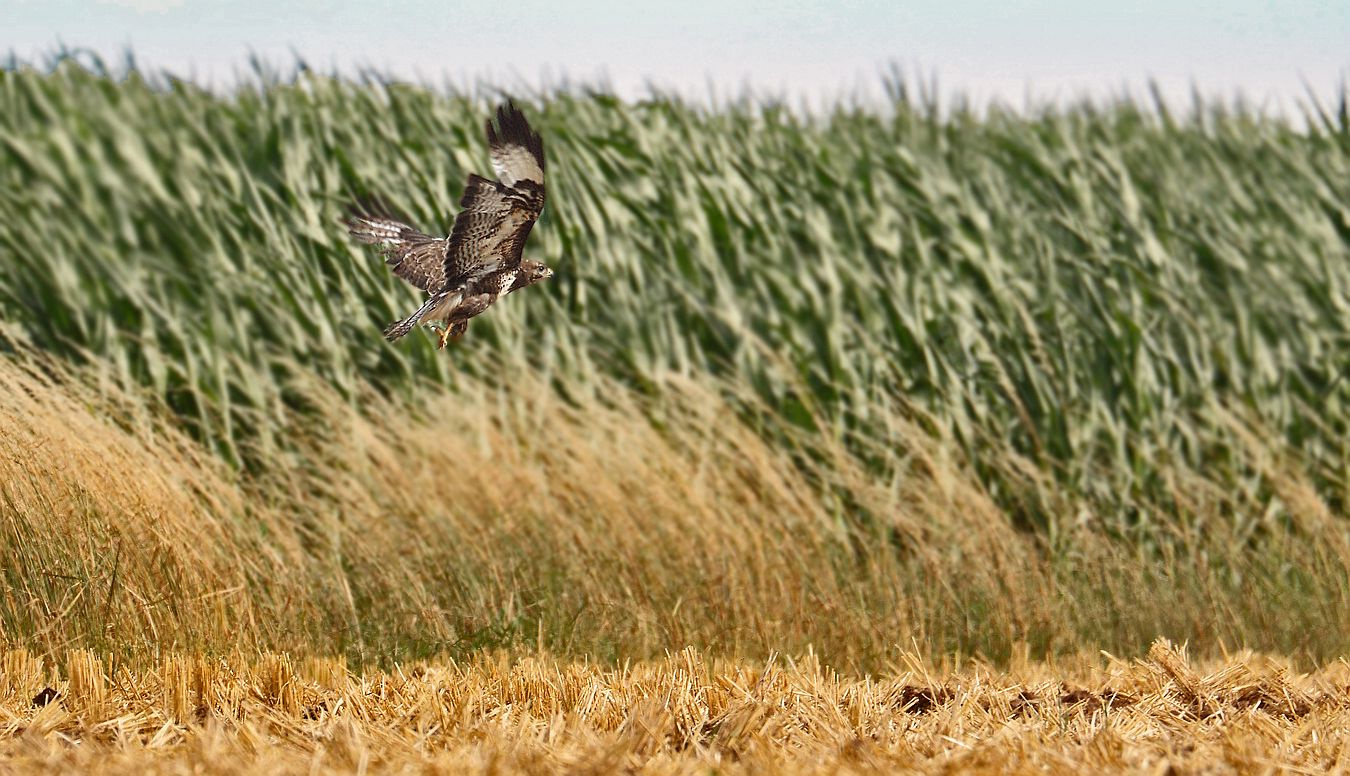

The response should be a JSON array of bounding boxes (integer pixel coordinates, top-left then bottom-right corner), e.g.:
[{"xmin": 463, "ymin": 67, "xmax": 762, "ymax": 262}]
[{"xmin": 0, "ymin": 54, "xmax": 1350, "ymax": 667}]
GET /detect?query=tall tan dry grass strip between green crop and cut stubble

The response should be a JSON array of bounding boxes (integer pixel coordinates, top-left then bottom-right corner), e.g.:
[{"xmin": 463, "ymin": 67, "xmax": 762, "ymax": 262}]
[{"xmin": 0, "ymin": 345, "xmax": 1350, "ymax": 671}]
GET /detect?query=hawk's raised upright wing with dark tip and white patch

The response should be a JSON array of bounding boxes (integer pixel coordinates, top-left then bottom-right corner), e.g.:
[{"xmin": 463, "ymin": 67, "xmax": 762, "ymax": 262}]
[{"xmin": 446, "ymin": 103, "xmax": 544, "ymax": 285}]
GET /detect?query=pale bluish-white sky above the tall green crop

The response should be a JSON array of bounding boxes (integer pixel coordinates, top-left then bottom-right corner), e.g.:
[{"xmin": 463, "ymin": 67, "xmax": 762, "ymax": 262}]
[{"xmin": 0, "ymin": 0, "xmax": 1350, "ymax": 111}]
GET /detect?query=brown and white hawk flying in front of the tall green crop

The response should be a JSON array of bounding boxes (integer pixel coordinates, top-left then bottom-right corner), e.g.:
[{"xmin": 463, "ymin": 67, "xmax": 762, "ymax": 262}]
[{"xmin": 346, "ymin": 101, "xmax": 554, "ymax": 348}]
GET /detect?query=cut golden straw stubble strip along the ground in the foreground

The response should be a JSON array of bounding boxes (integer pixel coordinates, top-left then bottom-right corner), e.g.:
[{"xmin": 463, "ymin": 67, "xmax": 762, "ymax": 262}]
[{"xmin": 0, "ymin": 642, "xmax": 1350, "ymax": 773}]
